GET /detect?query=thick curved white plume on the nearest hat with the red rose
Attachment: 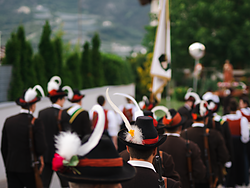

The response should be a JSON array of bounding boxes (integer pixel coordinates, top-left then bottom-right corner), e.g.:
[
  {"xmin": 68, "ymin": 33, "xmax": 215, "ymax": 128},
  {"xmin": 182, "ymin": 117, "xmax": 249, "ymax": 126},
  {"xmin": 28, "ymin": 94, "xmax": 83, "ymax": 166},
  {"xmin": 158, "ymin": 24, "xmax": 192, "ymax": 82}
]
[{"xmin": 77, "ymin": 105, "xmax": 105, "ymax": 156}]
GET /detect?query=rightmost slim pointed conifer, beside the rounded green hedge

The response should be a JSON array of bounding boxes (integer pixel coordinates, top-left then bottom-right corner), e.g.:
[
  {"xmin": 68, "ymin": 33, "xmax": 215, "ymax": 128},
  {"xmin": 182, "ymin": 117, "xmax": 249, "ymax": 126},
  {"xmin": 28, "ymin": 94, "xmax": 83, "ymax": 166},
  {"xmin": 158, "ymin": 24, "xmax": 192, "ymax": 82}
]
[{"xmin": 91, "ymin": 33, "xmax": 106, "ymax": 87}]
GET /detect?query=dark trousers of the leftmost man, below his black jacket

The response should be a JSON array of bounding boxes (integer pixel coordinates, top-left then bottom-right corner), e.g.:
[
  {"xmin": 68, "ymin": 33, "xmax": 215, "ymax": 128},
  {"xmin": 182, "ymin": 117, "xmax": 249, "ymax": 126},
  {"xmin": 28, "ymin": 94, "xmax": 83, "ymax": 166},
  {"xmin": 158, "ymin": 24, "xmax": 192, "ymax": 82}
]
[{"xmin": 6, "ymin": 171, "xmax": 36, "ymax": 188}]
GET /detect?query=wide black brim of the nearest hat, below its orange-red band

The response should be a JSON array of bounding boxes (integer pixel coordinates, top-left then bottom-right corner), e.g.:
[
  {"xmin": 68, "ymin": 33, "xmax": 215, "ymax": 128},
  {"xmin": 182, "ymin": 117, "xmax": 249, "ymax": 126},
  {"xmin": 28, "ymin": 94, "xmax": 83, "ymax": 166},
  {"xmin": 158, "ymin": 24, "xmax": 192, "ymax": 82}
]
[{"xmin": 59, "ymin": 160, "xmax": 136, "ymax": 183}]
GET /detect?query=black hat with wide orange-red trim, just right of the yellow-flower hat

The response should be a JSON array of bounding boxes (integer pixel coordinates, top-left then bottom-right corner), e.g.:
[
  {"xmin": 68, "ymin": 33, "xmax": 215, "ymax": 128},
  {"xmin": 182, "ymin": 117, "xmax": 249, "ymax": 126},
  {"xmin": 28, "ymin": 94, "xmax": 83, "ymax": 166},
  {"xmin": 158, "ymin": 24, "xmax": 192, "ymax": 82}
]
[{"xmin": 158, "ymin": 109, "xmax": 186, "ymax": 129}]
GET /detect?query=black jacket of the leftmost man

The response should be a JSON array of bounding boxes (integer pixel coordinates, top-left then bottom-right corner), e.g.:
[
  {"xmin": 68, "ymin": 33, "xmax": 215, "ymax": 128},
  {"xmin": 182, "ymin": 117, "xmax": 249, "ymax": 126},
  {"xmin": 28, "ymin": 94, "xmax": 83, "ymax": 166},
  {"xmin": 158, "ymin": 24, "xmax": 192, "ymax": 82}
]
[{"xmin": 1, "ymin": 113, "xmax": 46, "ymax": 172}]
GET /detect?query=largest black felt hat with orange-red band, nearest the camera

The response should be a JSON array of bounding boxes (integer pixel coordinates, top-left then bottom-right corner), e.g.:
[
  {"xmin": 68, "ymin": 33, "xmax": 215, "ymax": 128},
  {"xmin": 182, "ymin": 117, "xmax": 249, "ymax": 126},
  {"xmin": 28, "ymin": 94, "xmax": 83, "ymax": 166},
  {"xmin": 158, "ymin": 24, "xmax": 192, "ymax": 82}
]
[{"xmin": 59, "ymin": 135, "xmax": 136, "ymax": 184}]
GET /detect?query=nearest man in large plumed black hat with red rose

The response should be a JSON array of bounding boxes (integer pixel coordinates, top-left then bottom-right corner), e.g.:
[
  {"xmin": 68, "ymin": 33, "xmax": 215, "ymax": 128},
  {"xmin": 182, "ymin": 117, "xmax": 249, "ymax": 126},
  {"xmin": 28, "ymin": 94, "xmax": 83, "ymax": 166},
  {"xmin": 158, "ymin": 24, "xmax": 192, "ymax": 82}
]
[{"xmin": 53, "ymin": 105, "xmax": 136, "ymax": 188}]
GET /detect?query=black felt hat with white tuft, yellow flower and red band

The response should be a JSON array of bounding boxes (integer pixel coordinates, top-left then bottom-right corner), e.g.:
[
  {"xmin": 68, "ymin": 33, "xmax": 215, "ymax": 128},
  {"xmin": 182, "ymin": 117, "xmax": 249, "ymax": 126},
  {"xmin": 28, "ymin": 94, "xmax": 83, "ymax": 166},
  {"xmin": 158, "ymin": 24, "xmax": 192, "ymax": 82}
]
[{"xmin": 118, "ymin": 116, "xmax": 167, "ymax": 150}]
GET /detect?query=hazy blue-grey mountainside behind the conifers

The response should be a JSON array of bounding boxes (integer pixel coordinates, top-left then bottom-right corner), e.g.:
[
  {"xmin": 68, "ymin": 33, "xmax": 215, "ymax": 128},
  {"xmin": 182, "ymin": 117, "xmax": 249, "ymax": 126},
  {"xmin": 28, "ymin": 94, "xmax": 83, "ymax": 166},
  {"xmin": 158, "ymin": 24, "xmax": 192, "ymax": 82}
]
[{"xmin": 0, "ymin": 0, "xmax": 150, "ymax": 55}]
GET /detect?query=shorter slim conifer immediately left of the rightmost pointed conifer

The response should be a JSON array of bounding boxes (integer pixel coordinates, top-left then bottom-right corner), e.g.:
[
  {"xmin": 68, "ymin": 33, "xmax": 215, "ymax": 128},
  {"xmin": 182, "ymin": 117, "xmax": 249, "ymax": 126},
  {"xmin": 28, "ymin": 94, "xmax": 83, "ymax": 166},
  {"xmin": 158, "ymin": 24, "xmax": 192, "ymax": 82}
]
[{"xmin": 80, "ymin": 41, "xmax": 94, "ymax": 89}]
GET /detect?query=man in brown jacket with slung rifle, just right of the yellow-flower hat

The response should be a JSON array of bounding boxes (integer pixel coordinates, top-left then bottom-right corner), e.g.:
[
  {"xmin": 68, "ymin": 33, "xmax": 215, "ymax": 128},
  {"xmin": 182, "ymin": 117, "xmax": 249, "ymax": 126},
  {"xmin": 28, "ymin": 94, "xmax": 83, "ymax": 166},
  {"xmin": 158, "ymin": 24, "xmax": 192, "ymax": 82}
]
[{"xmin": 158, "ymin": 109, "xmax": 206, "ymax": 188}]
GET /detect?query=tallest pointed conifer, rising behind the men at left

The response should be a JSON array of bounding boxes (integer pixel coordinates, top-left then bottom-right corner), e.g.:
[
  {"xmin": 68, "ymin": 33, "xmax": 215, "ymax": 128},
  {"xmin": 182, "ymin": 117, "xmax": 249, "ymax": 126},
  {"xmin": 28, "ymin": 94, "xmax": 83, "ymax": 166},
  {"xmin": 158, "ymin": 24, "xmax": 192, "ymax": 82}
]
[{"xmin": 39, "ymin": 21, "xmax": 58, "ymax": 80}]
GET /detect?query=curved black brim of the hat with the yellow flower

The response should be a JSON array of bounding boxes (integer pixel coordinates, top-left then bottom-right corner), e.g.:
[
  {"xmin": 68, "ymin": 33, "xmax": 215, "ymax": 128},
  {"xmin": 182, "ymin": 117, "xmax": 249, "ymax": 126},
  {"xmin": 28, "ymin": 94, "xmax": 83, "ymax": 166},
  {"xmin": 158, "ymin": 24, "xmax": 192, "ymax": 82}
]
[{"xmin": 118, "ymin": 128, "xmax": 167, "ymax": 150}]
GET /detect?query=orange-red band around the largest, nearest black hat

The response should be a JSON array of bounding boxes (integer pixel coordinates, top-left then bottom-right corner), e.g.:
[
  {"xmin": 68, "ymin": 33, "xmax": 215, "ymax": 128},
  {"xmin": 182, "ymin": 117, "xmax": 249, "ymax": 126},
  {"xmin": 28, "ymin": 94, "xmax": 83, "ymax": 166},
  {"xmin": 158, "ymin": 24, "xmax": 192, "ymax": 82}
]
[{"xmin": 77, "ymin": 157, "xmax": 123, "ymax": 167}]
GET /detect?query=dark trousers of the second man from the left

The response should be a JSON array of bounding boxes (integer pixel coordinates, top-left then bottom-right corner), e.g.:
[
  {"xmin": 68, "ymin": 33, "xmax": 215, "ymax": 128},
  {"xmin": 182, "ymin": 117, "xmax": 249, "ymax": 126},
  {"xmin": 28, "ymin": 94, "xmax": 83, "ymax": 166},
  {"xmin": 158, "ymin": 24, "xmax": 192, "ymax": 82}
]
[{"xmin": 41, "ymin": 163, "xmax": 69, "ymax": 188}]
